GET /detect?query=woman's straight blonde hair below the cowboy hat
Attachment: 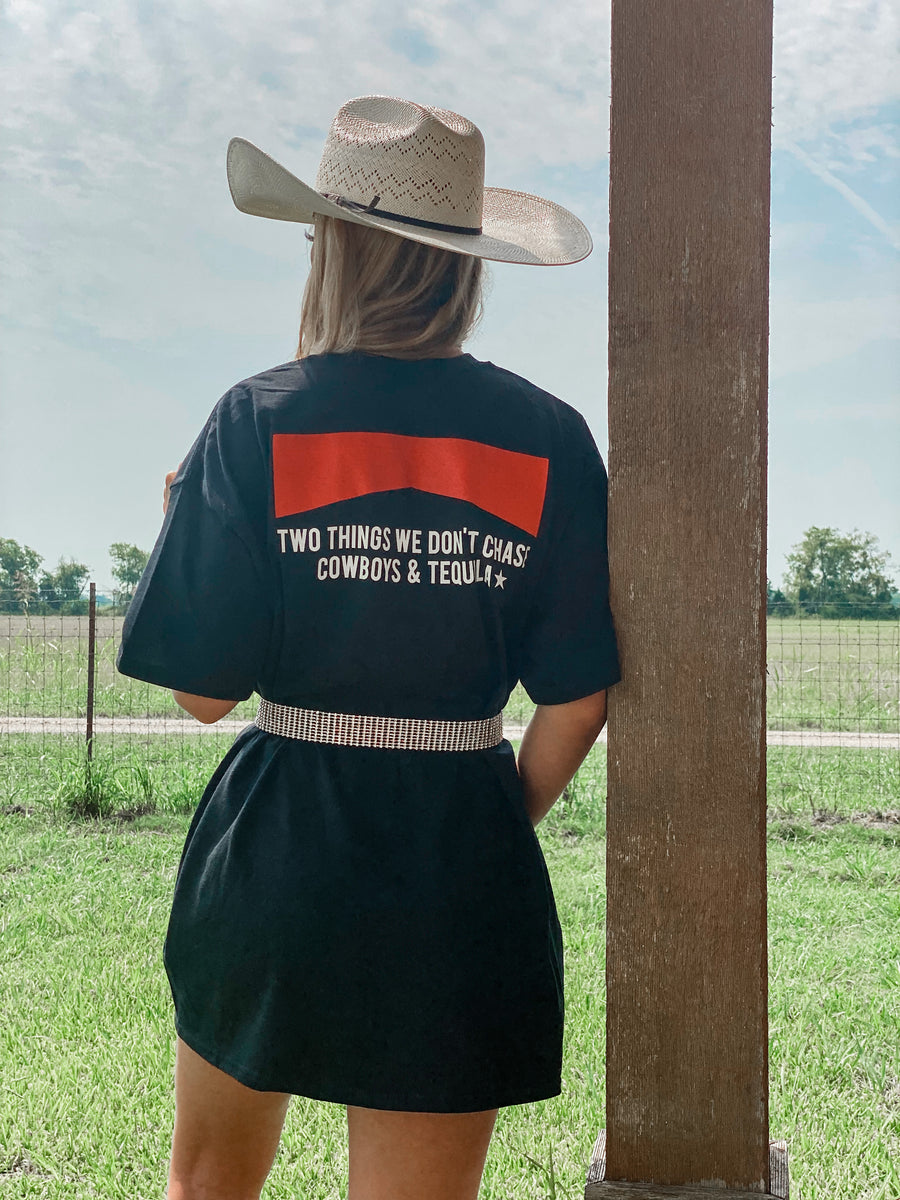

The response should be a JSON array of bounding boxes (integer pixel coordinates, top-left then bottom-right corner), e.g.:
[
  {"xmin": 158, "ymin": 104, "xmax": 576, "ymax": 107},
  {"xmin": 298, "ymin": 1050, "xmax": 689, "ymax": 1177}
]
[{"xmin": 296, "ymin": 215, "xmax": 482, "ymax": 359}]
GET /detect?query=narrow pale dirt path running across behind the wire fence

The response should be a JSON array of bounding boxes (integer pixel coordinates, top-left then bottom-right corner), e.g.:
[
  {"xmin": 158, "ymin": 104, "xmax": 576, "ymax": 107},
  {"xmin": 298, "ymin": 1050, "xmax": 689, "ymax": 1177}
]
[{"xmin": 0, "ymin": 716, "xmax": 900, "ymax": 750}]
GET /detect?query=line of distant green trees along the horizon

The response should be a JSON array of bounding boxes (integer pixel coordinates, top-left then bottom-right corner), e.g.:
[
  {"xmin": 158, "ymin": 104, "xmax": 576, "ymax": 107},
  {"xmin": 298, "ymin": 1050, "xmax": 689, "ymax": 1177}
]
[{"xmin": 0, "ymin": 526, "xmax": 900, "ymax": 619}]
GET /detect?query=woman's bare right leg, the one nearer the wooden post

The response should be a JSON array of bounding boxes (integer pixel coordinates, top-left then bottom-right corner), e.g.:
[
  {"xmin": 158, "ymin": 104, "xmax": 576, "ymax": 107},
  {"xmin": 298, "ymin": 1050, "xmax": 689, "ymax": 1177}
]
[{"xmin": 347, "ymin": 1105, "xmax": 499, "ymax": 1200}]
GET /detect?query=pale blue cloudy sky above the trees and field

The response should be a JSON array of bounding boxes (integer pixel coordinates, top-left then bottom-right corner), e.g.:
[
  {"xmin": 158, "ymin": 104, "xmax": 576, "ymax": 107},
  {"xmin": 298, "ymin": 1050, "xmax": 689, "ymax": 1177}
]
[{"xmin": 0, "ymin": 0, "xmax": 900, "ymax": 590}]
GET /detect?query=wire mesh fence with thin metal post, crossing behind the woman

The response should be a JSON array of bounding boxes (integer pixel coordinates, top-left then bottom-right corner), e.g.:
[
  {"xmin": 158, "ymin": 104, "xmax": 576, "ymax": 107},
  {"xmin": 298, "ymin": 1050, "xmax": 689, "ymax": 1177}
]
[{"xmin": 0, "ymin": 592, "xmax": 900, "ymax": 817}]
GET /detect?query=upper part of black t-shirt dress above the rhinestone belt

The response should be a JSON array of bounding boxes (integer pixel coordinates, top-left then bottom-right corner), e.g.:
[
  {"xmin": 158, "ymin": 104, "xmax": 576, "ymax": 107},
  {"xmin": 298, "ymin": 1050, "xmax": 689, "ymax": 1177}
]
[{"xmin": 118, "ymin": 353, "xmax": 620, "ymax": 720}]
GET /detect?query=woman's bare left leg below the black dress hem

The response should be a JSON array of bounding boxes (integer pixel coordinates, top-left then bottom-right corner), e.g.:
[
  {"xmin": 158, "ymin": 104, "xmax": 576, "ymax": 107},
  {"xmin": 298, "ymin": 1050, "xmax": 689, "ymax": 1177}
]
[{"xmin": 167, "ymin": 1038, "xmax": 290, "ymax": 1200}]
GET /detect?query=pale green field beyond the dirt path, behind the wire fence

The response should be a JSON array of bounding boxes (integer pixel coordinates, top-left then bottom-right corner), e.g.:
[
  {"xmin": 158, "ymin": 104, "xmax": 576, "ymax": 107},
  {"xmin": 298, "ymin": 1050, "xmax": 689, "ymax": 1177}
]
[{"xmin": 0, "ymin": 617, "xmax": 900, "ymax": 733}]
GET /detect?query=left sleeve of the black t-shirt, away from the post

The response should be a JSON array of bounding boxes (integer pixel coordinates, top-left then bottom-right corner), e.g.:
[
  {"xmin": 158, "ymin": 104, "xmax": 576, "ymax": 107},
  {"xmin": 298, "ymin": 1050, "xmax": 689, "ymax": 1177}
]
[{"xmin": 116, "ymin": 402, "xmax": 271, "ymax": 700}]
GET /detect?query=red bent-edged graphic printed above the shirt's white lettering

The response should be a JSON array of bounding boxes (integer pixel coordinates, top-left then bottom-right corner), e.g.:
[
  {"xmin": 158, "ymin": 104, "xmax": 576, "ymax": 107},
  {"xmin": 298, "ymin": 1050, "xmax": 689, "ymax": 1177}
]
[{"xmin": 272, "ymin": 433, "xmax": 548, "ymax": 535}]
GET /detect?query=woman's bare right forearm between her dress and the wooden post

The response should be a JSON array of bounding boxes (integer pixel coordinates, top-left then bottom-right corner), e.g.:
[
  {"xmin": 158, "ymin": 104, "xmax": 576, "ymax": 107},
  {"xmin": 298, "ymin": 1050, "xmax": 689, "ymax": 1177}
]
[{"xmin": 518, "ymin": 691, "xmax": 606, "ymax": 826}]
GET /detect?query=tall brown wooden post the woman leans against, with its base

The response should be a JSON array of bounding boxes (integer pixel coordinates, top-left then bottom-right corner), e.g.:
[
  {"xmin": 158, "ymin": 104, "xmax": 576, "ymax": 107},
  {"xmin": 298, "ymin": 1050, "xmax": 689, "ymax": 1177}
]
[{"xmin": 586, "ymin": 0, "xmax": 787, "ymax": 1200}]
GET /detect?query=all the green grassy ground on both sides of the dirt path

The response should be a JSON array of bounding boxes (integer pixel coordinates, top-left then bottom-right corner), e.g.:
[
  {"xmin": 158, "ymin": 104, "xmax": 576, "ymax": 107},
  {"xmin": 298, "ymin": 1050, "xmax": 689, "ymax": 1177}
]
[{"xmin": 0, "ymin": 618, "xmax": 900, "ymax": 1200}]
